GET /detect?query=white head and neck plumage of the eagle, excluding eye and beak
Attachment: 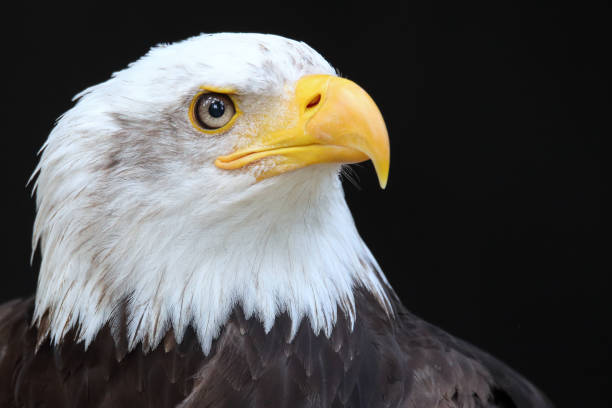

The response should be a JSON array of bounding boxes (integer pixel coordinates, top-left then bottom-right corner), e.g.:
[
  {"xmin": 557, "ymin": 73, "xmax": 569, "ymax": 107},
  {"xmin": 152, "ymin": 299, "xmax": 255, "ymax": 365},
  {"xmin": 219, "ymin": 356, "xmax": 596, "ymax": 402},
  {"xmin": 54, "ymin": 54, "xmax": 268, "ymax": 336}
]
[{"xmin": 33, "ymin": 34, "xmax": 391, "ymax": 353}]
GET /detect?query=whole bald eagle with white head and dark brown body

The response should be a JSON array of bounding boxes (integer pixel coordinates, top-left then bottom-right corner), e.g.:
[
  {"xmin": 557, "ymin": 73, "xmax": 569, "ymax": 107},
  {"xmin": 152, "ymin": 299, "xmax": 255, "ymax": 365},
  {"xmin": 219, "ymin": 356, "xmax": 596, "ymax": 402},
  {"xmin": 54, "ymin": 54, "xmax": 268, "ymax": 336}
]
[{"xmin": 0, "ymin": 33, "xmax": 551, "ymax": 408}]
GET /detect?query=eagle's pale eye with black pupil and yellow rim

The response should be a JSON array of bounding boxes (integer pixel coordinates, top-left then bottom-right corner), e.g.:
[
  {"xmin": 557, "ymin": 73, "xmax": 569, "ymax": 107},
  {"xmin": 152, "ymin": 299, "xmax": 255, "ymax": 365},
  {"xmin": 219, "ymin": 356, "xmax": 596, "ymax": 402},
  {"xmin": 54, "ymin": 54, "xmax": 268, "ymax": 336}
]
[{"xmin": 191, "ymin": 92, "xmax": 236, "ymax": 131}]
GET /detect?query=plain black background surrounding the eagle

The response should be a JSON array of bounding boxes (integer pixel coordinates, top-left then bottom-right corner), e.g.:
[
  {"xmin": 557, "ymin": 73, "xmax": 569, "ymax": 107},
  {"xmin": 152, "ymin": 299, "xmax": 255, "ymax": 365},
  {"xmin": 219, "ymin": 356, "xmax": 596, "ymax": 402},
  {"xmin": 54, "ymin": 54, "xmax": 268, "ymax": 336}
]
[{"xmin": 0, "ymin": 1, "xmax": 612, "ymax": 407}]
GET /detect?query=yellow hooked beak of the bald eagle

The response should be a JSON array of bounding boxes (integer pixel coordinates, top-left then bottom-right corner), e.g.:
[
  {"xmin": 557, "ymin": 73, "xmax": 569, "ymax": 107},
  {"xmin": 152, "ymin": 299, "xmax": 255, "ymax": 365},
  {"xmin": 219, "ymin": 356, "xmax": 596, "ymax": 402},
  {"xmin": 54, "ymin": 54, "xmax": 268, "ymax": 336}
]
[{"xmin": 215, "ymin": 75, "xmax": 390, "ymax": 188}]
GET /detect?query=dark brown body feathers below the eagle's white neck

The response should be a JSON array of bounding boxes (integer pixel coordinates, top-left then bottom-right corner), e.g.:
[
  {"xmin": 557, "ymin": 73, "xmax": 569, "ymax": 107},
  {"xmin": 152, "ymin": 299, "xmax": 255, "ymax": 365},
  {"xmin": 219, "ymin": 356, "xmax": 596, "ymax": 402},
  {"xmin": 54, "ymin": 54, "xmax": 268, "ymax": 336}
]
[{"xmin": 0, "ymin": 291, "xmax": 552, "ymax": 408}]
